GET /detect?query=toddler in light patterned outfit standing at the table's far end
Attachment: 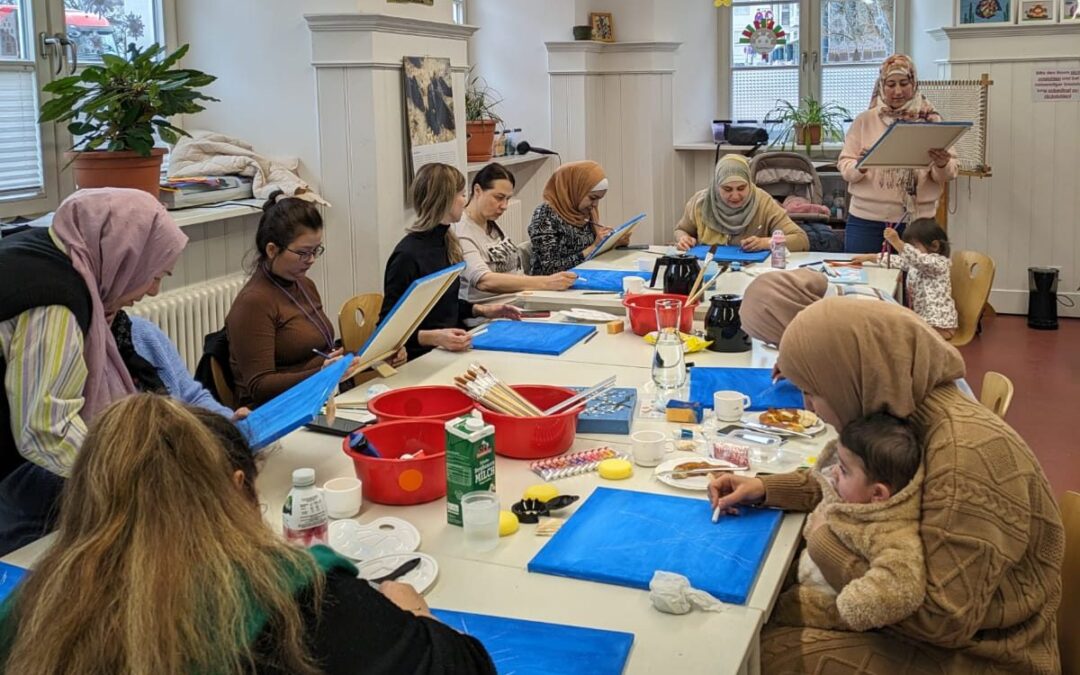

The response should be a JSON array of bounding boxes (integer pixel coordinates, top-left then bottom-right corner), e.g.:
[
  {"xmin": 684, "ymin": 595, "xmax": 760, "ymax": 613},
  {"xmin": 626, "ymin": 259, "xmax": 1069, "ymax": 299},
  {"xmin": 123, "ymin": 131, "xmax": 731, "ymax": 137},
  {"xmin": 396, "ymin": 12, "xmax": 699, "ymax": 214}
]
[{"xmin": 853, "ymin": 218, "xmax": 958, "ymax": 340}]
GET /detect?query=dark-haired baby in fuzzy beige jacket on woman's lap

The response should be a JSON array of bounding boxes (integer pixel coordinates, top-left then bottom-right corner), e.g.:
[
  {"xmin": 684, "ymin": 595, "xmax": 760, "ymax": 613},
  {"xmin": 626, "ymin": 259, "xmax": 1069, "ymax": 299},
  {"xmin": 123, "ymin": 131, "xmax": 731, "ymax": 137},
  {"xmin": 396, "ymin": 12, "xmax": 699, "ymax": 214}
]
[{"xmin": 774, "ymin": 413, "xmax": 927, "ymax": 631}]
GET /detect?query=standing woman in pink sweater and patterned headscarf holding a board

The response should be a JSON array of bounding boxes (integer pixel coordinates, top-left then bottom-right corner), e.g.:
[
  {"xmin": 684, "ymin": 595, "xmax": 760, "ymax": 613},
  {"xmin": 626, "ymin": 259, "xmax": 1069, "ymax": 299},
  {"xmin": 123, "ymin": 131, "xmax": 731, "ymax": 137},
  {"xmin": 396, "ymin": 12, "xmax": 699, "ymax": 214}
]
[{"xmin": 838, "ymin": 54, "xmax": 957, "ymax": 253}]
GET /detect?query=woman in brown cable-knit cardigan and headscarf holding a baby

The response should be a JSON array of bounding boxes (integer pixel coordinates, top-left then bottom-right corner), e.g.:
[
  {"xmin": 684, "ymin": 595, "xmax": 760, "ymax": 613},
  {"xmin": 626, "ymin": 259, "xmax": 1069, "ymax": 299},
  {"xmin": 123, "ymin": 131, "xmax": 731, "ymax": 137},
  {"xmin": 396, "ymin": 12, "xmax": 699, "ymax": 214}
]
[{"xmin": 710, "ymin": 298, "xmax": 1064, "ymax": 675}]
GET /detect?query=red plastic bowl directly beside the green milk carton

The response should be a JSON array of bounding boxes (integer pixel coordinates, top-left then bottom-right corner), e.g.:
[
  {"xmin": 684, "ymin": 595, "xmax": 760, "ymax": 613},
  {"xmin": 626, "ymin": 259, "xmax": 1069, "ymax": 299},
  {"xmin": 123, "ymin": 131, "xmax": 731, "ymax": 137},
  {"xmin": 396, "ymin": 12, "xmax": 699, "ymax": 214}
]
[{"xmin": 341, "ymin": 419, "xmax": 446, "ymax": 505}]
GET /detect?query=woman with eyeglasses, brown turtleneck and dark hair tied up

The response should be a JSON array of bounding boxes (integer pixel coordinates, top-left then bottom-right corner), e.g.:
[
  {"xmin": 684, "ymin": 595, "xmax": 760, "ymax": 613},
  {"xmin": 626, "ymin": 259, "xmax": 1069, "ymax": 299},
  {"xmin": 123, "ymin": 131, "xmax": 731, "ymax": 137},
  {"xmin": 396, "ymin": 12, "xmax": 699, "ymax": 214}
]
[{"xmin": 225, "ymin": 190, "xmax": 341, "ymax": 405}]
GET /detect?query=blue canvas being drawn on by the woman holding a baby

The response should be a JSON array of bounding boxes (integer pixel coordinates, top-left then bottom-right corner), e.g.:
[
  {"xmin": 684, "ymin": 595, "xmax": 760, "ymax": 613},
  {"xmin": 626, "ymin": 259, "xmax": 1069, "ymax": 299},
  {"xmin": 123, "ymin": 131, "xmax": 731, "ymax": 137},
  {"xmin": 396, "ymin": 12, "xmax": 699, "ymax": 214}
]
[{"xmin": 528, "ymin": 487, "xmax": 784, "ymax": 605}]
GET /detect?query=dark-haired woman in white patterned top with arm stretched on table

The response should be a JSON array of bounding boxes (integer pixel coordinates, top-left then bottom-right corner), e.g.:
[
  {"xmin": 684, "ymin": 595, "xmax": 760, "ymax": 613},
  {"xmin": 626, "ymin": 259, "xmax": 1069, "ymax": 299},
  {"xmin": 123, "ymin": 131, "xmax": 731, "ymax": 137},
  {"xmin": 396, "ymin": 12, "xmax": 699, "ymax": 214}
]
[{"xmin": 454, "ymin": 163, "xmax": 577, "ymax": 302}]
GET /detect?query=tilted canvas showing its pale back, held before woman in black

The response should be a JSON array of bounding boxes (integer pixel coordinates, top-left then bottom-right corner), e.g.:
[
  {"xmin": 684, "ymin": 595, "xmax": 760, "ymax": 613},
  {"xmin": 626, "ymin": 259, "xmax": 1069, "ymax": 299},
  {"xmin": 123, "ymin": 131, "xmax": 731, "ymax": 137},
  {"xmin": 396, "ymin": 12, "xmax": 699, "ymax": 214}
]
[{"xmin": 356, "ymin": 262, "xmax": 465, "ymax": 369}]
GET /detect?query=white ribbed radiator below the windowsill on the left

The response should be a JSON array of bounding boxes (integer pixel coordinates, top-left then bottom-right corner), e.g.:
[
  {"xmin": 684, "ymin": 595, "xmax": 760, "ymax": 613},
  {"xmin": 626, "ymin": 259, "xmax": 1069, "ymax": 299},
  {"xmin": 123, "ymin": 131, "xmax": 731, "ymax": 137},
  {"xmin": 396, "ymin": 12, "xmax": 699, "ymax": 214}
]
[{"xmin": 130, "ymin": 273, "xmax": 247, "ymax": 373}]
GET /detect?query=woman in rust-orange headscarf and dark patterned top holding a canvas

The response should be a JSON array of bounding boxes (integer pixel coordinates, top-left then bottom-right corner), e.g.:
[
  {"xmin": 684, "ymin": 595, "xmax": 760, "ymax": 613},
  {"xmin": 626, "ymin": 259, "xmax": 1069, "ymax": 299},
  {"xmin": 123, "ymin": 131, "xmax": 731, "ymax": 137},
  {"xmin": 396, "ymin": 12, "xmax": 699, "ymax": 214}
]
[{"xmin": 529, "ymin": 161, "xmax": 630, "ymax": 275}]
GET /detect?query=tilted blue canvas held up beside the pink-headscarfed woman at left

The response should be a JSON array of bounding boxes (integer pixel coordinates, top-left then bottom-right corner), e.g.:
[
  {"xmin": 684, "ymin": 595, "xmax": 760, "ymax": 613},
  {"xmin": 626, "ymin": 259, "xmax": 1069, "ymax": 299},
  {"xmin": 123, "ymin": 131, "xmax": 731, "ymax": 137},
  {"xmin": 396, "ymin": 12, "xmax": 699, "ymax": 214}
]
[{"xmin": 237, "ymin": 354, "xmax": 355, "ymax": 450}]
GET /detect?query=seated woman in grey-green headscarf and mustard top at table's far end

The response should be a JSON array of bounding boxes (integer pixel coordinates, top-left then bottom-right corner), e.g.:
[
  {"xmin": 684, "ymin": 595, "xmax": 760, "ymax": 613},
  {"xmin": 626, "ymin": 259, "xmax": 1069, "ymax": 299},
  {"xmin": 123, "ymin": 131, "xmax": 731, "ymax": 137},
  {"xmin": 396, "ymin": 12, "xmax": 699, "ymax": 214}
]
[{"xmin": 675, "ymin": 154, "xmax": 810, "ymax": 252}]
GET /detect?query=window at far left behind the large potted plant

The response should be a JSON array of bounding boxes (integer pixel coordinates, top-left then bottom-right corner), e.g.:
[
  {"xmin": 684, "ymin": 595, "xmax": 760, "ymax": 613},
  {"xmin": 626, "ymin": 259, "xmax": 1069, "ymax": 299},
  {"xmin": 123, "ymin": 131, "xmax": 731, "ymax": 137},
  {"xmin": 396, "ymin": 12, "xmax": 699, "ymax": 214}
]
[{"xmin": 0, "ymin": 0, "xmax": 168, "ymax": 216}]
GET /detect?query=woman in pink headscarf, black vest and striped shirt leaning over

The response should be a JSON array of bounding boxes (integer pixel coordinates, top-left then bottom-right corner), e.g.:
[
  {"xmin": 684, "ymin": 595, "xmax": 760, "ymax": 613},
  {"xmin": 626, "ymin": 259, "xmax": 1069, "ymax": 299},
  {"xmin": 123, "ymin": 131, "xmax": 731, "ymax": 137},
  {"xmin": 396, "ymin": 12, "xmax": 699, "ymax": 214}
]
[{"xmin": 0, "ymin": 189, "xmax": 188, "ymax": 554}]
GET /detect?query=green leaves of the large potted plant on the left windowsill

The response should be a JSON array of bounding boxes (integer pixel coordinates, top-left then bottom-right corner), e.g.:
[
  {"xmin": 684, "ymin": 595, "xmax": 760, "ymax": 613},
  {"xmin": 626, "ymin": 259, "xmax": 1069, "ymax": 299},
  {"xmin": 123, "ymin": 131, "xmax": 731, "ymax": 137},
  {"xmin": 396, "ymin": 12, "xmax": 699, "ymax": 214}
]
[{"xmin": 38, "ymin": 44, "xmax": 217, "ymax": 157}]
